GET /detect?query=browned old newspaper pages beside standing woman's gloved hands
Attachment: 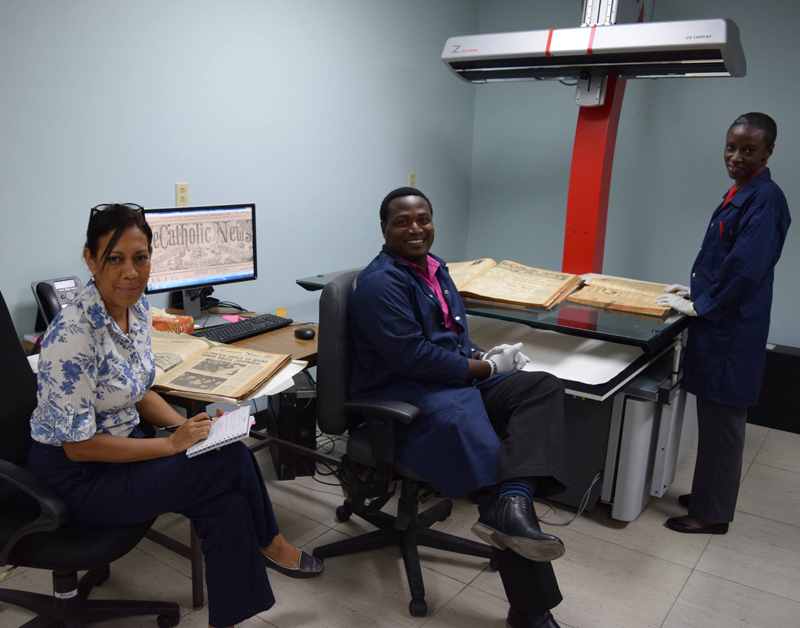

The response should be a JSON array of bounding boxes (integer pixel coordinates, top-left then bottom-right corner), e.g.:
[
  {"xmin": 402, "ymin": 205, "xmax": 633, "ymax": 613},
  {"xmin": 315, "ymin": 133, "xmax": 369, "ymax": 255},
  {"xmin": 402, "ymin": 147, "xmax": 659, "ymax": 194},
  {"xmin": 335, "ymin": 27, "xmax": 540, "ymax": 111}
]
[{"xmin": 567, "ymin": 277, "xmax": 672, "ymax": 316}]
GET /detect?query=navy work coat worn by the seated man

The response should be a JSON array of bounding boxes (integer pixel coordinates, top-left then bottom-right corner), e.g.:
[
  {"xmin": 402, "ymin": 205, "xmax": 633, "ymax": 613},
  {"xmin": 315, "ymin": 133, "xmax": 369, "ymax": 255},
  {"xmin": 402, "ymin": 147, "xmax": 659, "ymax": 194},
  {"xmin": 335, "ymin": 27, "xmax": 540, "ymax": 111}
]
[{"xmin": 347, "ymin": 246, "xmax": 505, "ymax": 497}]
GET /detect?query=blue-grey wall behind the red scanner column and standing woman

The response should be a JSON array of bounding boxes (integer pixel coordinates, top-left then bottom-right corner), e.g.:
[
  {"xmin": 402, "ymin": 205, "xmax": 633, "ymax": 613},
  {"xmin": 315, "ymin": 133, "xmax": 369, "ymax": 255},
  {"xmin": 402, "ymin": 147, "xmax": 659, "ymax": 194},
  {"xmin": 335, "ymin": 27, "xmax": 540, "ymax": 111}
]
[{"xmin": 467, "ymin": 0, "xmax": 800, "ymax": 346}]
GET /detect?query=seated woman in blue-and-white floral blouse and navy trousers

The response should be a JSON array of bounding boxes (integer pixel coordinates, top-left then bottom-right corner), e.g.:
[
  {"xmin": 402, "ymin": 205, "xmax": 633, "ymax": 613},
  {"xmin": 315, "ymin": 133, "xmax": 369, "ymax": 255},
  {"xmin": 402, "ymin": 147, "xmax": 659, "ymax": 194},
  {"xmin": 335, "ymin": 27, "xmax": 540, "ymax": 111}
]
[{"xmin": 27, "ymin": 205, "xmax": 322, "ymax": 628}]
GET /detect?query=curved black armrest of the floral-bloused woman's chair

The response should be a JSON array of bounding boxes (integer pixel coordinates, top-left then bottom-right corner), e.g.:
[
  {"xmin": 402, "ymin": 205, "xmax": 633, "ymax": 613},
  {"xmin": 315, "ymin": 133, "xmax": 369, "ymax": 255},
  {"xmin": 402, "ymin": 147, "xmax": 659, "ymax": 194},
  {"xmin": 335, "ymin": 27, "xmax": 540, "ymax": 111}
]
[{"xmin": 0, "ymin": 460, "xmax": 69, "ymax": 565}]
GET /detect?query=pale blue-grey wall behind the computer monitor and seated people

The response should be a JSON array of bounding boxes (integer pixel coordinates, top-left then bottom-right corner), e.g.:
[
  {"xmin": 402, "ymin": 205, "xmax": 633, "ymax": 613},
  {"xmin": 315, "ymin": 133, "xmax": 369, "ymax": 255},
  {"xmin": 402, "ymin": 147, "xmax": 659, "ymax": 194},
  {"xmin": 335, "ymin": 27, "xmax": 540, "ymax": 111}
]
[{"xmin": 0, "ymin": 0, "xmax": 478, "ymax": 333}]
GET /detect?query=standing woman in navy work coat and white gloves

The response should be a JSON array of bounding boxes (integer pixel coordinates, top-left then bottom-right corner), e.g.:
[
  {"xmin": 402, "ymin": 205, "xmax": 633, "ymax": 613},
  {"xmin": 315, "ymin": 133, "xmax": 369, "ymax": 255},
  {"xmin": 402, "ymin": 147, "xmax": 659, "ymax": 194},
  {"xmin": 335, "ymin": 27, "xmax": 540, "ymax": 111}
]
[{"xmin": 656, "ymin": 113, "xmax": 791, "ymax": 534}]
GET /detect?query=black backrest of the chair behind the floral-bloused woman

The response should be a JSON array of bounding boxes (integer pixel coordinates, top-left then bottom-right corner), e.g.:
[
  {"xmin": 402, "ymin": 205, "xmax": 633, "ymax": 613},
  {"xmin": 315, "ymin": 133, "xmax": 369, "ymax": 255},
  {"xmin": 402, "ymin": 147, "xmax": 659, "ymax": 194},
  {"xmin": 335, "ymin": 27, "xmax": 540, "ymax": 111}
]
[{"xmin": 0, "ymin": 293, "xmax": 36, "ymax": 464}]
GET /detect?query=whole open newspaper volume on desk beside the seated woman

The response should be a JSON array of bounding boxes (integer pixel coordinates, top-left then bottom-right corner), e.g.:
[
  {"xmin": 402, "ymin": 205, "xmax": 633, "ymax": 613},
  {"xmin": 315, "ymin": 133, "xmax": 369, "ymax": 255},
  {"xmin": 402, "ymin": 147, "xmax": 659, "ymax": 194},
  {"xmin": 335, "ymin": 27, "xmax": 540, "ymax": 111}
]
[{"xmin": 152, "ymin": 330, "xmax": 291, "ymax": 402}]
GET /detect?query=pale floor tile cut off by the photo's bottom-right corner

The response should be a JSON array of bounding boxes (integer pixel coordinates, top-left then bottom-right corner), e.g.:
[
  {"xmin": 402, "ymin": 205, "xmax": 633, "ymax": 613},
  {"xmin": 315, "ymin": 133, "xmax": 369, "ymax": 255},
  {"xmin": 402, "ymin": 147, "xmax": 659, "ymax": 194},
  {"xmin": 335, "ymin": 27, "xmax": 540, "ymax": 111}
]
[{"xmin": 664, "ymin": 571, "xmax": 800, "ymax": 628}]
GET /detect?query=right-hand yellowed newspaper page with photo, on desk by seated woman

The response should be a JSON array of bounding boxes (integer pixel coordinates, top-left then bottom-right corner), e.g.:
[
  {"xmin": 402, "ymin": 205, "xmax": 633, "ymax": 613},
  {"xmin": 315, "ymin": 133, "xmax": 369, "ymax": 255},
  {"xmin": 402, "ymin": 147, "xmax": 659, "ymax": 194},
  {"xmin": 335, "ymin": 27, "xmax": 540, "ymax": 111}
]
[{"xmin": 155, "ymin": 345, "xmax": 291, "ymax": 399}]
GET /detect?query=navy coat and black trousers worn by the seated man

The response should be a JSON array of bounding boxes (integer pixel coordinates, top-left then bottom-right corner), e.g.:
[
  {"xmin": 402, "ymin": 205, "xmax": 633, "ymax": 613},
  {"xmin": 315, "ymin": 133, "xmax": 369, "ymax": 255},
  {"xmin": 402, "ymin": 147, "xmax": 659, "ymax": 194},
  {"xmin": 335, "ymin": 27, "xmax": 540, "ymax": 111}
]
[{"xmin": 348, "ymin": 246, "xmax": 566, "ymax": 613}]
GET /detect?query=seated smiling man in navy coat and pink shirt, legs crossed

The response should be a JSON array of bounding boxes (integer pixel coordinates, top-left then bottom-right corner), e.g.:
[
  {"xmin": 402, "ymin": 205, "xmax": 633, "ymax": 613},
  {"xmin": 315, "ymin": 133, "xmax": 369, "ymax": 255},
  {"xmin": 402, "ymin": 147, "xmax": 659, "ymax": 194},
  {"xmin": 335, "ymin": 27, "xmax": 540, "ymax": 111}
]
[{"xmin": 348, "ymin": 188, "xmax": 565, "ymax": 628}]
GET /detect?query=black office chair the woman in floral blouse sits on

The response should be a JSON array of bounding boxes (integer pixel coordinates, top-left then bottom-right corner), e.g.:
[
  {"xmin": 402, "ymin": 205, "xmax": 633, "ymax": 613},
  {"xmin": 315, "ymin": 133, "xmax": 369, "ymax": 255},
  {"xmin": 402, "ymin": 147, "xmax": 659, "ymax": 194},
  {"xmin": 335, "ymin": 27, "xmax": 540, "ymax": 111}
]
[{"xmin": 0, "ymin": 294, "xmax": 181, "ymax": 628}]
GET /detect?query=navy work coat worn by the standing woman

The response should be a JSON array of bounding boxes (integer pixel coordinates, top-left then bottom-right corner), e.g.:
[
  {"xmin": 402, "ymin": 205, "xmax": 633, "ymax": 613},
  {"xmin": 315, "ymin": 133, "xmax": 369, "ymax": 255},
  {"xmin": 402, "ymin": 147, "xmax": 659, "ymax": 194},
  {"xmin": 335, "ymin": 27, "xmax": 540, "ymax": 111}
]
[{"xmin": 683, "ymin": 169, "xmax": 791, "ymax": 406}]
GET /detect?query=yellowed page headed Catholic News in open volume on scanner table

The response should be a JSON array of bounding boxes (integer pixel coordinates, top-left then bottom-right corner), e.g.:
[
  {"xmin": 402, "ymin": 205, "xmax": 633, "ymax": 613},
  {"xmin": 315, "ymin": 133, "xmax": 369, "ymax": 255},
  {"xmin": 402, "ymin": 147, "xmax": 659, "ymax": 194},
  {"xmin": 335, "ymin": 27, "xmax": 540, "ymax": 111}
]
[{"xmin": 461, "ymin": 260, "xmax": 581, "ymax": 308}]
